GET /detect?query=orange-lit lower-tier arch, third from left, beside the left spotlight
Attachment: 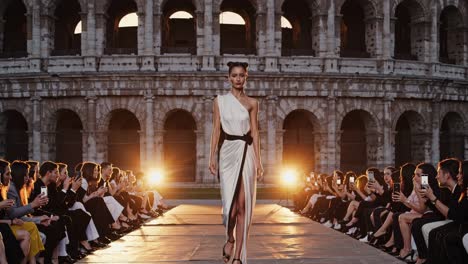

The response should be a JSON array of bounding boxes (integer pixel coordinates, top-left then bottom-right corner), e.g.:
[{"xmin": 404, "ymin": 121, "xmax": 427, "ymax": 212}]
[{"xmin": 107, "ymin": 109, "xmax": 141, "ymax": 171}]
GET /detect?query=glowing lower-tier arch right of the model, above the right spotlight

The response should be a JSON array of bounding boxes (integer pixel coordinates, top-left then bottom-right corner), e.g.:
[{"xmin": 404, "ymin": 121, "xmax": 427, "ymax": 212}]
[{"xmin": 283, "ymin": 110, "xmax": 315, "ymax": 174}]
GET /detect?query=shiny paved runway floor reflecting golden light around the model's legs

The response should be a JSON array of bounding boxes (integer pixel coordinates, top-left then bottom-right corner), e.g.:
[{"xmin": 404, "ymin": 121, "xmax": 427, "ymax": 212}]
[{"xmin": 81, "ymin": 204, "xmax": 402, "ymax": 264}]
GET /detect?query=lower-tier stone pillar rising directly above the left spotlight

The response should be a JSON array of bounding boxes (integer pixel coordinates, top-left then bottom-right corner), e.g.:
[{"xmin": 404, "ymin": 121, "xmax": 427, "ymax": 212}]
[{"xmin": 144, "ymin": 94, "xmax": 154, "ymax": 168}]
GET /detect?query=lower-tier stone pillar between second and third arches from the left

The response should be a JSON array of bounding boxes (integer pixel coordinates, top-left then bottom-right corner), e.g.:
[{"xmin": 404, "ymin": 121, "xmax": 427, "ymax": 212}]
[{"xmin": 84, "ymin": 96, "xmax": 97, "ymax": 161}]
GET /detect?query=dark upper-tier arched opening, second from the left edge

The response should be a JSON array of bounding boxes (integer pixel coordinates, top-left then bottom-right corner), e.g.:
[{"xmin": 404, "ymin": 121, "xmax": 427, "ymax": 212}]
[{"xmin": 52, "ymin": 0, "xmax": 81, "ymax": 56}]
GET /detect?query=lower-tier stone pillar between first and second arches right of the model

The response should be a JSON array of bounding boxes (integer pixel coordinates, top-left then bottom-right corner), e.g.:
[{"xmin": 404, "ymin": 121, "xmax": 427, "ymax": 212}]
[{"xmin": 326, "ymin": 95, "xmax": 340, "ymax": 171}]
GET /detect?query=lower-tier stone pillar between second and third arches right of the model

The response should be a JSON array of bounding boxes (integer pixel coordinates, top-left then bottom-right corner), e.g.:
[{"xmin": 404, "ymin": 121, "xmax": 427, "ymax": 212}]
[{"xmin": 382, "ymin": 97, "xmax": 395, "ymax": 166}]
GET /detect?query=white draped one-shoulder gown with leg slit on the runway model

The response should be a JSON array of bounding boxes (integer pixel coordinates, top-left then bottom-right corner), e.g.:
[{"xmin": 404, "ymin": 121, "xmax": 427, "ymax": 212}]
[{"xmin": 218, "ymin": 92, "xmax": 256, "ymax": 264}]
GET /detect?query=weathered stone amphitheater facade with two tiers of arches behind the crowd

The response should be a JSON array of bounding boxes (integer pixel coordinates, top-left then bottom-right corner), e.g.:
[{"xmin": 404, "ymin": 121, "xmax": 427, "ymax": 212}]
[{"xmin": 0, "ymin": 0, "xmax": 468, "ymax": 184}]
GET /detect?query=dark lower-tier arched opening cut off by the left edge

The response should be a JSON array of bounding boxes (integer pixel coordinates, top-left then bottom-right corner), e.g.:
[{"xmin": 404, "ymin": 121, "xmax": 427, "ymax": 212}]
[{"xmin": 0, "ymin": 110, "xmax": 29, "ymax": 161}]
